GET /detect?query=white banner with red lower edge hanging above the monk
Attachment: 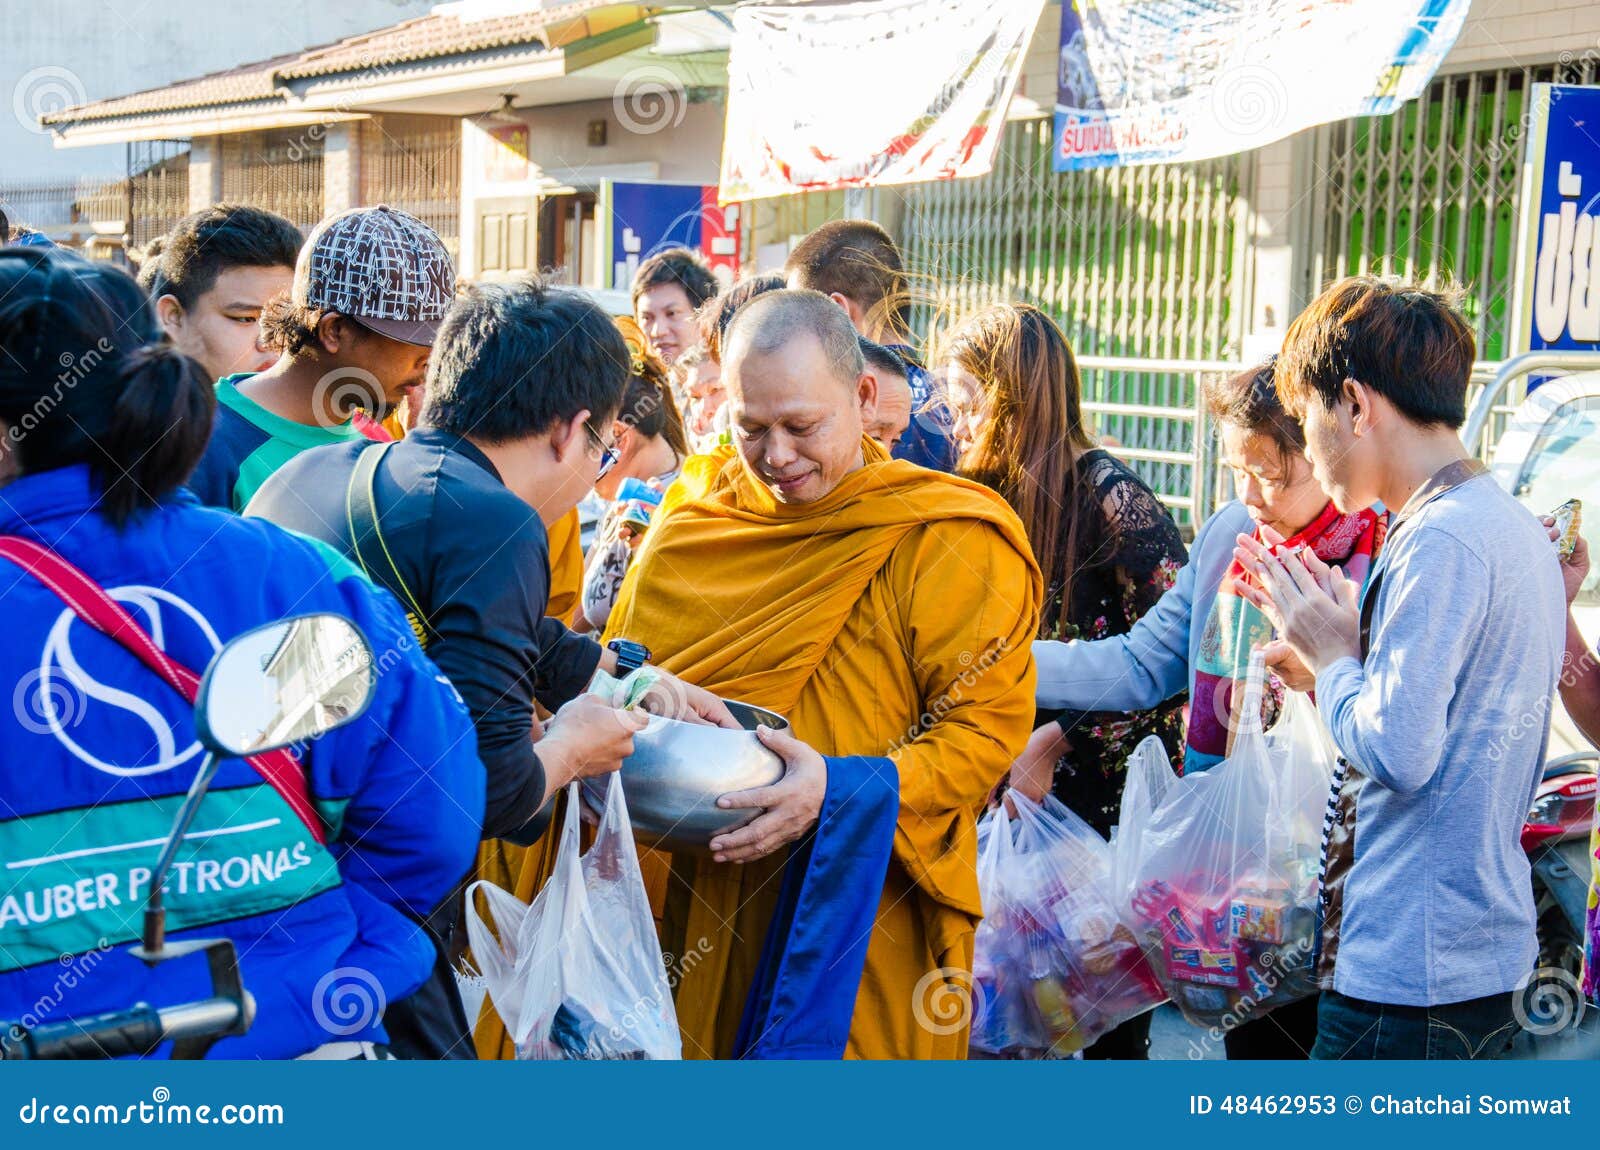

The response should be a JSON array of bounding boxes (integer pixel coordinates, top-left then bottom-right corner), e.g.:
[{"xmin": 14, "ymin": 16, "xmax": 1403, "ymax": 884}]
[{"xmin": 718, "ymin": 0, "xmax": 1043, "ymax": 203}]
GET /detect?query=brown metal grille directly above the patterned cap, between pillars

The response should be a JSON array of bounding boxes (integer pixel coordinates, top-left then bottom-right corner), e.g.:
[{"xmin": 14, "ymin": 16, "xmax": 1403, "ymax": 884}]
[{"xmin": 360, "ymin": 115, "xmax": 461, "ymax": 256}]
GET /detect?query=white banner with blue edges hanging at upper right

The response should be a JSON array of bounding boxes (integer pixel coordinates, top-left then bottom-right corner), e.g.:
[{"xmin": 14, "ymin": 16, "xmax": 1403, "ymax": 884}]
[{"xmin": 1054, "ymin": 0, "xmax": 1469, "ymax": 171}]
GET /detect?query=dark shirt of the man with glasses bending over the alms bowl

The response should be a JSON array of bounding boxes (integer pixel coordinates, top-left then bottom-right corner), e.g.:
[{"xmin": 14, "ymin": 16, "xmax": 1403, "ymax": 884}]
[{"xmin": 245, "ymin": 429, "xmax": 600, "ymax": 845}]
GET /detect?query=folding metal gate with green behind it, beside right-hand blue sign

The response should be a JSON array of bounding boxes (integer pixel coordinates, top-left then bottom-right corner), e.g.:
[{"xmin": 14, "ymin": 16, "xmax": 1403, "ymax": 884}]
[{"xmin": 1296, "ymin": 53, "xmax": 1595, "ymax": 360}]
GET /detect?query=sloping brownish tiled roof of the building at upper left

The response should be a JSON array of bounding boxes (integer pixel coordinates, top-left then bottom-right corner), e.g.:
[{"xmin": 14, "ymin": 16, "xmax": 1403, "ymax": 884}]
[{"xmin": 40, "ymin": 0, "xmax": 664, "ymax": 125}]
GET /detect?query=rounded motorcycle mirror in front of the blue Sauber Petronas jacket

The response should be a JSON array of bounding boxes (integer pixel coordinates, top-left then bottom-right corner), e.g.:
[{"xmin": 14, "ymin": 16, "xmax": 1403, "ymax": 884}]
[{"xmin": 195, "ymin": 614, "xmax": 378, "ymax": 757}]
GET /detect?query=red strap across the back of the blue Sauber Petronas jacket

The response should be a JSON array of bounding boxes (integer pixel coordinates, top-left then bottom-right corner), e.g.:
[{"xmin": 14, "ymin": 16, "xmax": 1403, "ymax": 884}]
[{"xmin": 0, "ymin": 536, "xmax": 326, "ymax": 845}]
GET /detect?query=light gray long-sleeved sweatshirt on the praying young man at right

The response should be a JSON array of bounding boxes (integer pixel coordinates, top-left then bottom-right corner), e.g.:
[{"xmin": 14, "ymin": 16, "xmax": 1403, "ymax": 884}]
[{"xmin": 1317, "ymin": 475, "xmax": 1566, "ymax": 1006}]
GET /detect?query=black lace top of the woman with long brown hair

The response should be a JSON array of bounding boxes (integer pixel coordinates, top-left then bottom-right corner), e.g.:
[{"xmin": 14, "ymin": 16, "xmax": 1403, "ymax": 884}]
[{"xmin": 1038, "ymin": 448, "xmax": 1189, "ymax": 835}]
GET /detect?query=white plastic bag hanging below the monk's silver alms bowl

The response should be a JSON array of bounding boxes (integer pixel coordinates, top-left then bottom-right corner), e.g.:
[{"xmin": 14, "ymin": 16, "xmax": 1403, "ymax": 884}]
[{"xmin": 467, "ymin": 774, "xmax": 683, "ymax": 1060}]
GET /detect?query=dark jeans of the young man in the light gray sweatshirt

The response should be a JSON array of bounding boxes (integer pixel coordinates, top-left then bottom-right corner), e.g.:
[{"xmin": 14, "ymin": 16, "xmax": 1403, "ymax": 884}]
[{"xmin": 1310, "ymin": 990, "xmax": 1517, "ymax": 1060}]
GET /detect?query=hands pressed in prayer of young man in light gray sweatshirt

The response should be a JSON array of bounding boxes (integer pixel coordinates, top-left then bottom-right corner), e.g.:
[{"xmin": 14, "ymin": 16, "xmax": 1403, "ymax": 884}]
[{"xmin": 1234, "ymin": 534, "xmax": 1362, "ymax": 686}]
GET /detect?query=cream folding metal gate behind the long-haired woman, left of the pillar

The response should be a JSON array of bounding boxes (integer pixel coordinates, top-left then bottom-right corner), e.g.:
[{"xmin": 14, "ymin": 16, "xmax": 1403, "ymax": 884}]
[{"xmin": 901, "ymin": 120, "xmax": 1254, "ymax": 517}]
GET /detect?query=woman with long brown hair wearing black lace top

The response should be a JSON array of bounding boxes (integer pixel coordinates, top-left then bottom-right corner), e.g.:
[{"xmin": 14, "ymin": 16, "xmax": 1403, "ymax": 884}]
[{"xmin": 946, "ymin": 304, "xmax": 1186, "ymax": 1057}]
